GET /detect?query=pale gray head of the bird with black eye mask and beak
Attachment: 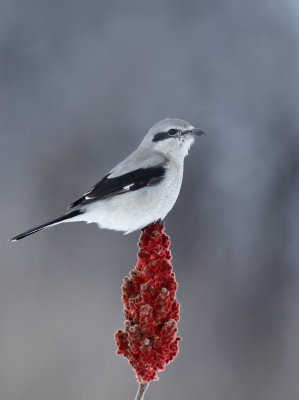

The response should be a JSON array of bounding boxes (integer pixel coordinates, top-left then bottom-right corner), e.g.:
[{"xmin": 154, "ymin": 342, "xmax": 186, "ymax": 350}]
[{"xmin": 141, "ymin": 118, "xmax": 204, "ymax": 158}]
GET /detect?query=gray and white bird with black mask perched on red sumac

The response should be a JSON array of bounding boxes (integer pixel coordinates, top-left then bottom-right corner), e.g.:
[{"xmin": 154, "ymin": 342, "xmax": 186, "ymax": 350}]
[{"xmin": 9, "ymin": 118, "xmax": 205, "ymax": 242}]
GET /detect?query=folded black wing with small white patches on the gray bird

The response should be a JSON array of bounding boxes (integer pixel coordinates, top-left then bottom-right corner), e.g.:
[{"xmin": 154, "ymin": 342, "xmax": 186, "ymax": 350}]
[{"xmin": 68, "ymin": 166, "xmax": 166, "ymax": 208}]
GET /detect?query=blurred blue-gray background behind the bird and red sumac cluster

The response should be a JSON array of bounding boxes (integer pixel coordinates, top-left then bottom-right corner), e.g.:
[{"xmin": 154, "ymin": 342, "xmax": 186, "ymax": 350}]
[{"xmin": 0, "ymin": 0, "xmax": 299, "ymax": 400}]
